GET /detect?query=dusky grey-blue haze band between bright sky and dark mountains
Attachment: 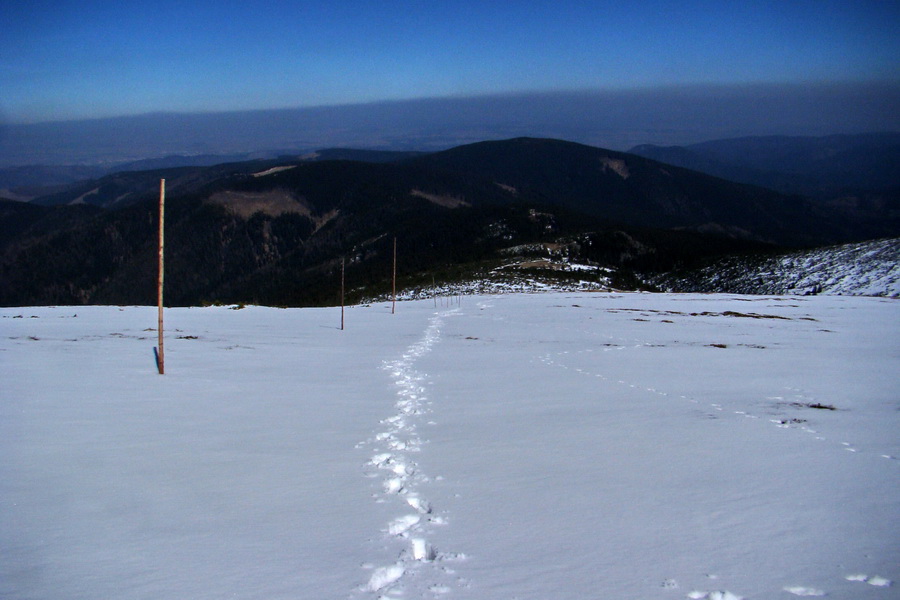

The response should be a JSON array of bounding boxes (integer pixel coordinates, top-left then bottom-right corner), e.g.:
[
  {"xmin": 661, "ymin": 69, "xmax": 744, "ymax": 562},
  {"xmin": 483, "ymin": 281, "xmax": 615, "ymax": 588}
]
[{"xmin": 0, "ymin": 83, "xmax": 900, "ymax": 167}]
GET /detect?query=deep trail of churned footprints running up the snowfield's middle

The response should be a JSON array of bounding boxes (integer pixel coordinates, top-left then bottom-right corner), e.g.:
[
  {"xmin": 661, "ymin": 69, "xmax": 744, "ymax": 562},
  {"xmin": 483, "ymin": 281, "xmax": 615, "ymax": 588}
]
[{"xmin": 359, "ymin": 309, "xmax": 465, "ymax": 599}]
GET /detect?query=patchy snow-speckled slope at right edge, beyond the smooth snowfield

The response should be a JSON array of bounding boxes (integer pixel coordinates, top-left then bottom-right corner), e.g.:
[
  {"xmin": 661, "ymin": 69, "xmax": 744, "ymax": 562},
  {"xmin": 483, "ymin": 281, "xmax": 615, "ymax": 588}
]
[{"xmin": 659, "ymin": 238, "xmax": 900, "ymax": 298}]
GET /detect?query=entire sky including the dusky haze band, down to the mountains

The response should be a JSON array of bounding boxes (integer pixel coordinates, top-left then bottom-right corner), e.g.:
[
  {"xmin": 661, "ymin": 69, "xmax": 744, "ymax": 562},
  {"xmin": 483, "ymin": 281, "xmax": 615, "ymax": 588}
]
[{"xmin": 7, "ymin": 0, "xmax": 900, "ymax": 166}]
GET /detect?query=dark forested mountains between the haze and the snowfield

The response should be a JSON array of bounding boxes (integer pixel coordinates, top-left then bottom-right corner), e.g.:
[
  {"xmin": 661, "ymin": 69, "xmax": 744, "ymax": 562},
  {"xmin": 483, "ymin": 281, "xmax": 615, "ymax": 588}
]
[{"xmin": 0, "ymin": 136, "xmax": 900, "ymax": 306}]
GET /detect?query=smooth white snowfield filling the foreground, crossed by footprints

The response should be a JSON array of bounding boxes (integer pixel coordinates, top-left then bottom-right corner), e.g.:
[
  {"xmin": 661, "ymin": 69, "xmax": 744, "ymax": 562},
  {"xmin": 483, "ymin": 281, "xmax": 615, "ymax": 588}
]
[{"xmin": 0, "ymin": 292, "xmax": 900, "ymax": 600}]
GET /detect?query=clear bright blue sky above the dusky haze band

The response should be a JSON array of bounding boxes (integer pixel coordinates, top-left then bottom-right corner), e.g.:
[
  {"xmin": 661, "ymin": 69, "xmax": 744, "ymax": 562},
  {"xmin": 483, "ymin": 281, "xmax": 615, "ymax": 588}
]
[{"xmin": 0, "ymin": 0, "xmax": 900, "ymax": 123}]
